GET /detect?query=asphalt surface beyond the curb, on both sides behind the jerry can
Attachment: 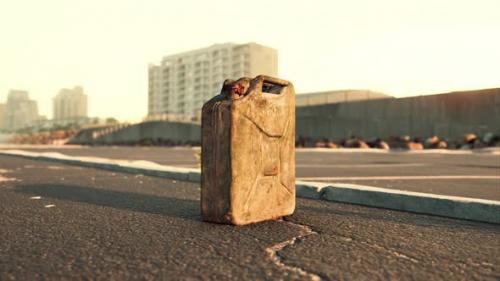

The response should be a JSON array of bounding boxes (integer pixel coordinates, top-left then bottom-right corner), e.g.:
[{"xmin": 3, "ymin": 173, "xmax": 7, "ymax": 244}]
[{"xmin": 10, "ymin": 146, "xmax": 500, "ymax": 201}]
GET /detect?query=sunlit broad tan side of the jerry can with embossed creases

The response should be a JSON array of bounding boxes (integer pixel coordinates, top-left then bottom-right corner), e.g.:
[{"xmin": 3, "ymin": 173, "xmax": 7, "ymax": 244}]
[{"xmin": 231, "ymin": 82, "xmax": 295, "ymax": 224}]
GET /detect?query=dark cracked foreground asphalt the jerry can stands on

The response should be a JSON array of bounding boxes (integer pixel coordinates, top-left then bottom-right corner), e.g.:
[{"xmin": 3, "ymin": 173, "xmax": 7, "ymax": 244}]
[{"xmin": 0, "ymin": 156, "xmax": 500, "ymax": 280}]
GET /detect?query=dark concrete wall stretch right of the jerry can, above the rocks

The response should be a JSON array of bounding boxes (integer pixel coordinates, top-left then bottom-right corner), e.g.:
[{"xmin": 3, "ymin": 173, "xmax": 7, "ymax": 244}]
[{"xmin": 296, "ymin": 88, "xmax": 500, "ymax": 139}]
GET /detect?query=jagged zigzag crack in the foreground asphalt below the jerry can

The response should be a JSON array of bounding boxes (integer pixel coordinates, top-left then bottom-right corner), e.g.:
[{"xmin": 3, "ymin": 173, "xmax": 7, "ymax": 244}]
[{"xmin": 266, "ymin": 220, "xmax": 321, "ymax": 281}]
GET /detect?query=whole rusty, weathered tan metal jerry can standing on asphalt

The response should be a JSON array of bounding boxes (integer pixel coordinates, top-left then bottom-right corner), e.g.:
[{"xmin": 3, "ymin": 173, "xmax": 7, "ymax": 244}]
[{"xmin": 201, "ymin": 76, "xmax": 295, "ymax": 225}]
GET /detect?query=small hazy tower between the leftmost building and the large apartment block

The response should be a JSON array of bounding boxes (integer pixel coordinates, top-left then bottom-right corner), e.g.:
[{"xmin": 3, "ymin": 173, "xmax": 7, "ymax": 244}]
[{"xmin": 53, "ymin": 87, "xmax": 87, "ymax": 123}]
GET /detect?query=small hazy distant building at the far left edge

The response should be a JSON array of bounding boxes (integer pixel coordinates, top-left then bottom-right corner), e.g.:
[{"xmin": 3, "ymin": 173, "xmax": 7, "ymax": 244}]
[{"xmin": 3, "ymin": 90, "xmax": 38, "ymax": 131}]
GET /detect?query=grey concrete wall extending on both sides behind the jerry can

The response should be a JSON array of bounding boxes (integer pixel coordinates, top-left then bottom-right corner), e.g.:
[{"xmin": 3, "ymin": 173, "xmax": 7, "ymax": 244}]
[{"xmin": 70, "ymin": 88, "xmax": 500, "ymax": 144}]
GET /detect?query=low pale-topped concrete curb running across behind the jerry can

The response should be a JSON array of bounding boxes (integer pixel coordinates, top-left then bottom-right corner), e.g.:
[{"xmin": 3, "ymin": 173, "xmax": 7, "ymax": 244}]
[{"xmin": 0, "ymin": 150, "xmax": 500, "ymax": 224}]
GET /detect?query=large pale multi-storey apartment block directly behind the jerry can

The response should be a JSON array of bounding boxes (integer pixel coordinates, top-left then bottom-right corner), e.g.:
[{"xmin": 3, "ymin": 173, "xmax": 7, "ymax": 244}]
[{"xmin": 148, "ymin": 43, "xmax": 278, "ymax": 118}]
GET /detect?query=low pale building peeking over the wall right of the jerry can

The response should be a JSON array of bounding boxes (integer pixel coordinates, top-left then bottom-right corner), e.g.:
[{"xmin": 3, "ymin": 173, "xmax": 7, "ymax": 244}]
[{"xmin": 295, "ymin": 90, "xmax": 394, "ymax": 106}]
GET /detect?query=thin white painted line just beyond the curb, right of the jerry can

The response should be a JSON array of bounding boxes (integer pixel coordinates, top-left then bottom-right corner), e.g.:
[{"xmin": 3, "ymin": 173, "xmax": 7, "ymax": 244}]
[{"xmin": 297, "ymin": 175, "xmax": 500, "ymax": 181}]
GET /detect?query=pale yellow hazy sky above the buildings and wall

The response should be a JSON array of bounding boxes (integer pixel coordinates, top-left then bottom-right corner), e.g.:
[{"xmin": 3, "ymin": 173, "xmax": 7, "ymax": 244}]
[{"xmin": 0, "ymin": 0, "xmax": 500, "ymax": 120}]
